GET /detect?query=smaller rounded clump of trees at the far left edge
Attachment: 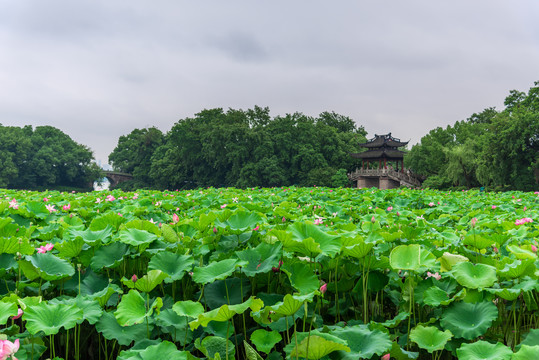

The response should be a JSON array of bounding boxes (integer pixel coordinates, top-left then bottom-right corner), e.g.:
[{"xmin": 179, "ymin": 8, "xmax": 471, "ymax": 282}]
[{"xmin": 0, "ymin": 124, "xmax": 101, "ymax": 190}]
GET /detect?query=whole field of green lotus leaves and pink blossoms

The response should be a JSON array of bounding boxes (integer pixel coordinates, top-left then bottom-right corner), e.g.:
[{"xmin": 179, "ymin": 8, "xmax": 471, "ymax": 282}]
[{"xmin": 0, "ymin": 187, "xmax": 539, "ymax": 360}]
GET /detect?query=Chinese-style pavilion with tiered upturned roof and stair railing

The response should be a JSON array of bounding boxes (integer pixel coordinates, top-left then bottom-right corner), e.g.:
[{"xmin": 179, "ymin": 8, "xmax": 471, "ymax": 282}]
[{"xmin": 348, "ymin": 133, "xmax": 421, "ymax": 189}]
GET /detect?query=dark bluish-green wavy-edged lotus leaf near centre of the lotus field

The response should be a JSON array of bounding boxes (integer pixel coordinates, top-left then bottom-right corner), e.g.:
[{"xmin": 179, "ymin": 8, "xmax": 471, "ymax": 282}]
[{"xmin": 236, "ymin": 242, "xmax": 282, "ymax": 277}]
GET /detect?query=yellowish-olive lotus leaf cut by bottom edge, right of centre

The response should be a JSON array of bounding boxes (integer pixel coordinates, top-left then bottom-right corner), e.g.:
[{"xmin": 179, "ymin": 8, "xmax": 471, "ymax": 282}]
[{"xmin": 285, "ymin": 331, "xmax": 350, "ymax": 360}]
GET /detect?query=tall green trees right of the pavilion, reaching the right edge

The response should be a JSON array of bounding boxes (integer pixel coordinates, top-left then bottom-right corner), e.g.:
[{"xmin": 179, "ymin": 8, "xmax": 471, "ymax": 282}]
[{"xmin": 405, "ymin": 82, "xmax": 539, "ymax": 191}]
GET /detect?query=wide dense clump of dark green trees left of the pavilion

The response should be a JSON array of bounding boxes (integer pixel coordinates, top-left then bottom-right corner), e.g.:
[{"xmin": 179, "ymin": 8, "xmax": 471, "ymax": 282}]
[{"xmin": 109, "ymin": 106, "xmax": 366, "ymax": 189}]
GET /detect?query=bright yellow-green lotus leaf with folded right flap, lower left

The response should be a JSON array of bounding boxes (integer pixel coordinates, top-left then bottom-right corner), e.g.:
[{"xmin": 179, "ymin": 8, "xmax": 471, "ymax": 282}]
[{"xmin": 114, "ymin": 290, "xmax": 163, "ymax": 326}]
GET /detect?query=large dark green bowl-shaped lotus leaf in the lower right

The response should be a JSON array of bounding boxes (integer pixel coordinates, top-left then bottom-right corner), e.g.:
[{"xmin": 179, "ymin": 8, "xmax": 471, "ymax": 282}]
[{"xmin": 440, "ymin": 301, "xmax": 498, "ymax": 340}]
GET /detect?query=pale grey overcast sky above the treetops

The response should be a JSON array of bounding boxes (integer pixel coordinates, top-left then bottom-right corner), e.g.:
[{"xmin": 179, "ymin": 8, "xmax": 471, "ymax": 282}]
[{"xmin": 0, "ymin": 0, "xmax": 539, "ymax": 164}]
